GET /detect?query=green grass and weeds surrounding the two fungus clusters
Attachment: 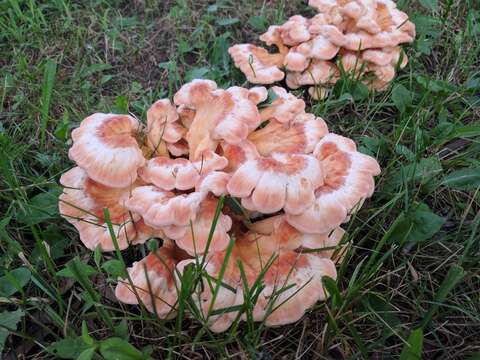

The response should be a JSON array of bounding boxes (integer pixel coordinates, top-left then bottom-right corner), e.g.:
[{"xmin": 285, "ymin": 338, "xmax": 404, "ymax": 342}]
[{"xmin": 0, "ymin": 0, "xmax": 480, "ymax": 359}]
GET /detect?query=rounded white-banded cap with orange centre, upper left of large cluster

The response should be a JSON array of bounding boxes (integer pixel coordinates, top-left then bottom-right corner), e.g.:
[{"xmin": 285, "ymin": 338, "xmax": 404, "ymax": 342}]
[{"xmin": 68, "ymin": 113, "xmax": 145, "ymax": 187}]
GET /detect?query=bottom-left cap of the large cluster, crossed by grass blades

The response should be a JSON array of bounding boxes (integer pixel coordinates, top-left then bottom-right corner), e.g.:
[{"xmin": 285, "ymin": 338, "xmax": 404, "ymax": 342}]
[{"xmin": 115, "ymin": 245, "xmax": 178, "ymax": 319}]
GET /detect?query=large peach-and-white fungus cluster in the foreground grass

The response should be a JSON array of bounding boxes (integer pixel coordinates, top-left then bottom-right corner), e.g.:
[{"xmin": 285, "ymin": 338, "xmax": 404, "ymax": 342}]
[{"xmin": 59, "ymin": 79, "xmax": 380, "ymax": 331}]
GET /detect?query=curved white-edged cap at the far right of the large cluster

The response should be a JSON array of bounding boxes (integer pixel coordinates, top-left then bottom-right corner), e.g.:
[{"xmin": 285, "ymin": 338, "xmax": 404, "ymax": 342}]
[{"xmin": 287, "ymin": 134, "xmax": 380, "ymax": 234}]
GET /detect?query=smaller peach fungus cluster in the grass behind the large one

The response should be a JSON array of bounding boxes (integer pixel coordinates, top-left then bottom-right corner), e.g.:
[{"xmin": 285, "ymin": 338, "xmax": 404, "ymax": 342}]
[{"xmin": 229, "ymin": 0, "xmax": 415, "ymax": 99}]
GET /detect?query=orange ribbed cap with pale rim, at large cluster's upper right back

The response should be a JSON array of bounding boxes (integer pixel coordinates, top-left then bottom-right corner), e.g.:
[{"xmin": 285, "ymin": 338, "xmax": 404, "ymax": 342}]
[{"xmin": 248, "ymin": 113, "xmax": 328, "ymax": 156}]
